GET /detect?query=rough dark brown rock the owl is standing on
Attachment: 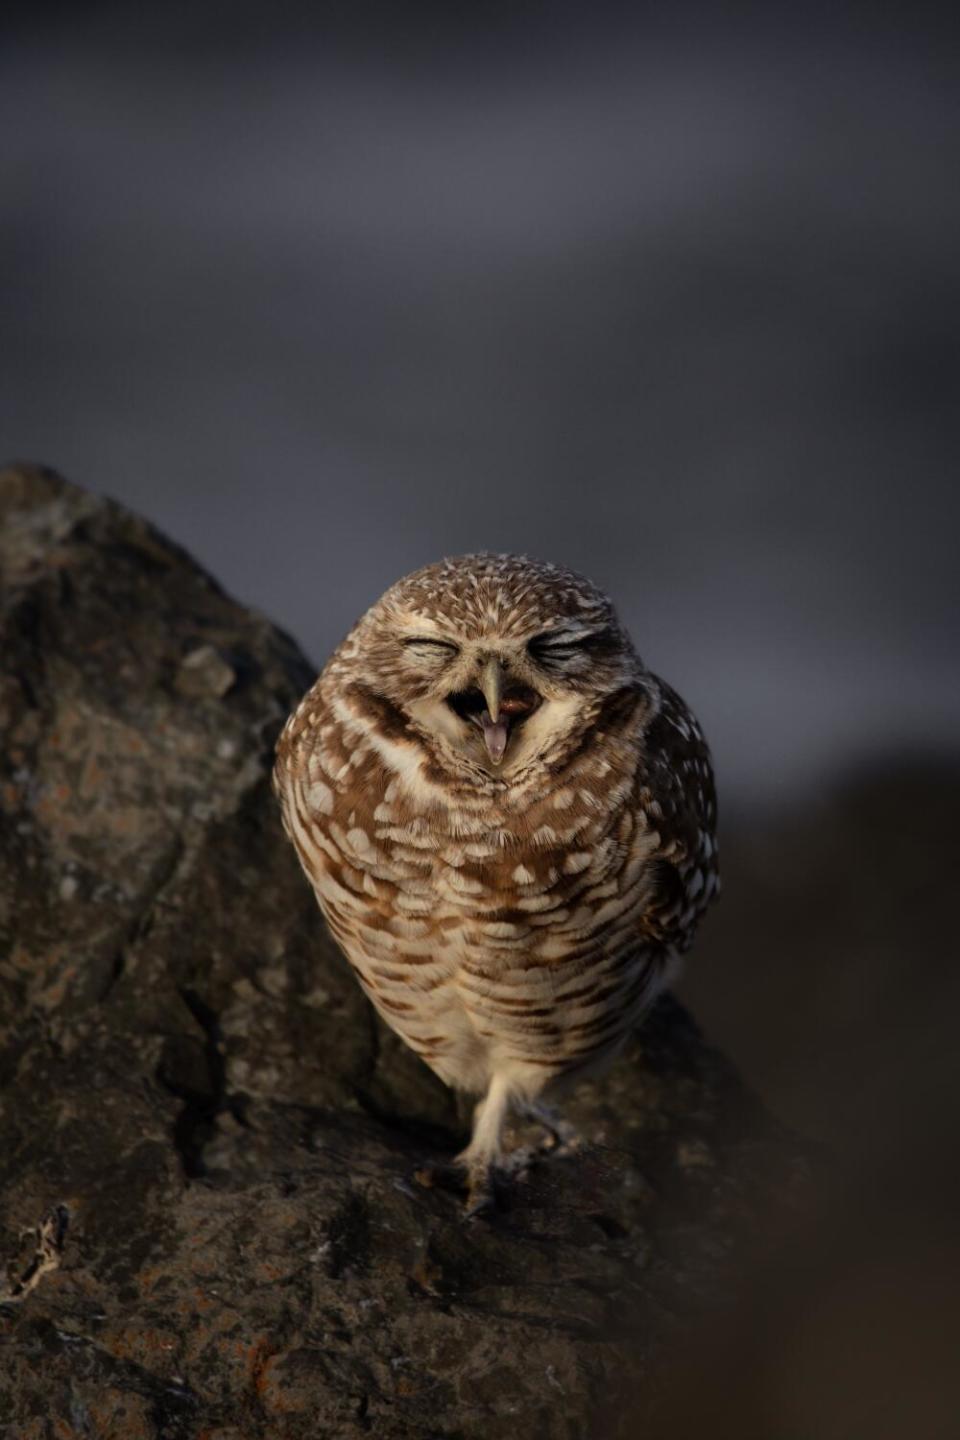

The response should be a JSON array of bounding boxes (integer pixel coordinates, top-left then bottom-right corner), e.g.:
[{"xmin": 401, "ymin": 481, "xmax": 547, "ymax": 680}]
[{"xmin": 0, "ymin": 467, "xmax": 805, "ymax": 1440}]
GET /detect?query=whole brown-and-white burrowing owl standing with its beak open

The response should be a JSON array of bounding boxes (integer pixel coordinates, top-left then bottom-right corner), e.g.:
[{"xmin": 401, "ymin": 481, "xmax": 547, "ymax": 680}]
[{"xmin": 275, "ymin": 554, "xmax": 718, "ymax": 1210}]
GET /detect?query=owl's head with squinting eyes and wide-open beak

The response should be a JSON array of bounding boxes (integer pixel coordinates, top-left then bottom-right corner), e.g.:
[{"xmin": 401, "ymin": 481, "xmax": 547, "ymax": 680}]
[{"xmin": 344, "ymin": 554, "xmax": 643, "ymax": 779}]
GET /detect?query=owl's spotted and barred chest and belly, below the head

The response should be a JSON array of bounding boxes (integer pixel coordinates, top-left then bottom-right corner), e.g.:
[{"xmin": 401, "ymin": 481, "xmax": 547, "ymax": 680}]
[{"xmin": 270, "ymin": 668, "xmax": 715, "ymax": 1093}]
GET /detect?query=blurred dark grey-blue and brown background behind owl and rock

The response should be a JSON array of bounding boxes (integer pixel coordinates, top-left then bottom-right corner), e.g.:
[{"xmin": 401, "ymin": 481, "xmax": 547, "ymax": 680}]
[{"xmin": 0, "ymin": 0, "xmax": 960, "ymax": 1437}]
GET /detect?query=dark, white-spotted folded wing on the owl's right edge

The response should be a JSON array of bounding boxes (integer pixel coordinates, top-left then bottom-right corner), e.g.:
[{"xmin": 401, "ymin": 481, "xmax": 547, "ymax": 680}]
[{"xmin": 638, "ymin": 680, "xmax": 720, "ymax": 950}]
